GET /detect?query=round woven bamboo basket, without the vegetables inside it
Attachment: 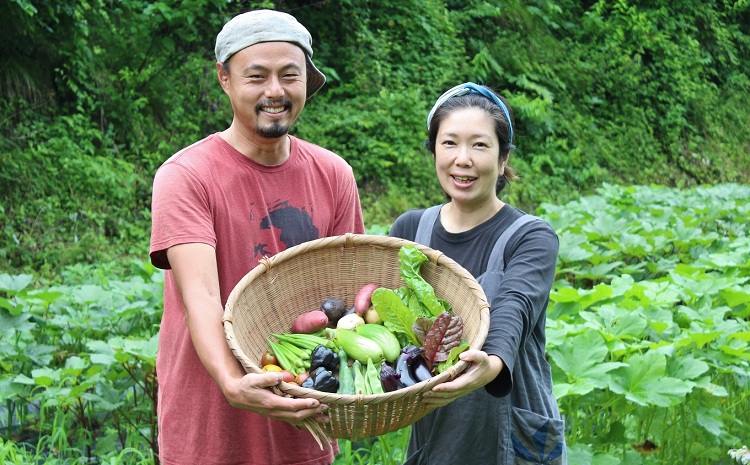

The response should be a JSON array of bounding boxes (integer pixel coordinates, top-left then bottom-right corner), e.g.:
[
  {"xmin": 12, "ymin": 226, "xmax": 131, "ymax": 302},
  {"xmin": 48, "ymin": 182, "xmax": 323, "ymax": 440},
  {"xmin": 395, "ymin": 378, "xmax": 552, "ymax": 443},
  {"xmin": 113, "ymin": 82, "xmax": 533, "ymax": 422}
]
[{"xmin": 223, "ymin": 234, "xmax": 489, "ymax": 447}]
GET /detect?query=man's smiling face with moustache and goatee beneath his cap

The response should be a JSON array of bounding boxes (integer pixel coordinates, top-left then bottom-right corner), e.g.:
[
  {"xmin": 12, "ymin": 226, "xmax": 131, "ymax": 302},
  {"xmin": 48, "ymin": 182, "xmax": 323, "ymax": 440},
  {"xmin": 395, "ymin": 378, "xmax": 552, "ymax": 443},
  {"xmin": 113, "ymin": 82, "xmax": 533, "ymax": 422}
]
[{"xmin": 217, "ymin": 42, "xmax": 307, "ymax": 138}]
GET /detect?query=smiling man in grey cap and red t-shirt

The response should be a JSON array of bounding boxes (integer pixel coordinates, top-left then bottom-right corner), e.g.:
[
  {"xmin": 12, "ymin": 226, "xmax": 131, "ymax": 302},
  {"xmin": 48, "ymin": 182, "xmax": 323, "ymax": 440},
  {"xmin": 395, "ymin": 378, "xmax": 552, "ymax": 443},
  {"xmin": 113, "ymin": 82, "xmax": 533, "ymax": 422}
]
[{"xmin": 150, "ymin": 10, "xmax": 364, "ymax": 465}]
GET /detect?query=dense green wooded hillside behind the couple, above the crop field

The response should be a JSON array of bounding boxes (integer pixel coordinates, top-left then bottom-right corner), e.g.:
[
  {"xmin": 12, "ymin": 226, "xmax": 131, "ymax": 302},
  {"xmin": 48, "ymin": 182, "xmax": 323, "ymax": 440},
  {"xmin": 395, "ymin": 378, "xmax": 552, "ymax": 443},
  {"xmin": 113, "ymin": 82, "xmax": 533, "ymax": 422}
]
[{"xmin": 0, "ymin": 0, "xmax": 750, "ymax": 274}]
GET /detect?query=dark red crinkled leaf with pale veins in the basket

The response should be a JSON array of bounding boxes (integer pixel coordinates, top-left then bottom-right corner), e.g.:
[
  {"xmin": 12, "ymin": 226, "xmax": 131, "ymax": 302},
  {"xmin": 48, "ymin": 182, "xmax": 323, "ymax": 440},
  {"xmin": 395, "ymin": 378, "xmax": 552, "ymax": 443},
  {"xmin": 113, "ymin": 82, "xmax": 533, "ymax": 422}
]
[{"xmin": 412, "ymin": 312, "xmax": 464, "ymax": 367}]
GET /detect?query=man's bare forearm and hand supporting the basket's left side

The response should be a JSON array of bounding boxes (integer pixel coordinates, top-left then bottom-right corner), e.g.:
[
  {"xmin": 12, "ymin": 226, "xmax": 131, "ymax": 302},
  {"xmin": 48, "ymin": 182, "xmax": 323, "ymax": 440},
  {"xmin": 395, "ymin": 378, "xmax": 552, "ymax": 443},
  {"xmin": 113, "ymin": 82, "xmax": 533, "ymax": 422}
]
[{"xmin": 167, "ymin": 243, "xmax": 327, "ymax": 423}]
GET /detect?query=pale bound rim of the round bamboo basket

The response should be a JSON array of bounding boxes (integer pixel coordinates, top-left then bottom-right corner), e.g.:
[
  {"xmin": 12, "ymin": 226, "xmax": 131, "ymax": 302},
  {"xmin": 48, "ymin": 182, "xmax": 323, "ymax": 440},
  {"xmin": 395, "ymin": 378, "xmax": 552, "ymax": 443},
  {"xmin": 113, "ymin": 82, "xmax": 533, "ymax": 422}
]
[{"xmin": 222, "ymin": 233, "xmax": 490, "ymax": 405}]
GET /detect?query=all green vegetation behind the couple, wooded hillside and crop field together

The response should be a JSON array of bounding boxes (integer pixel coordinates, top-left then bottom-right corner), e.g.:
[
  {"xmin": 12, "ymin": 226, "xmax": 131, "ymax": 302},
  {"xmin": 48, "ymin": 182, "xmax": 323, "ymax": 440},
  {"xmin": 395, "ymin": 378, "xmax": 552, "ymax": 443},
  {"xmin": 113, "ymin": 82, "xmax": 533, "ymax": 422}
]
[{"xmin": 0, "ymin": 0, "xmax": 750, "ymax": 465}]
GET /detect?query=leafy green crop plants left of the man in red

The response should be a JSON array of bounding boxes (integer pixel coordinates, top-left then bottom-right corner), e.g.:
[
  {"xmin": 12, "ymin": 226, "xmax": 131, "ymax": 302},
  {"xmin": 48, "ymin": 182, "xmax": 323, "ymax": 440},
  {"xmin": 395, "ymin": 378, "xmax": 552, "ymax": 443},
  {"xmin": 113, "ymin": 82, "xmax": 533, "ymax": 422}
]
[{"xmin": 0, "ymin": 263, "xmax": 163, "ymax": 463}]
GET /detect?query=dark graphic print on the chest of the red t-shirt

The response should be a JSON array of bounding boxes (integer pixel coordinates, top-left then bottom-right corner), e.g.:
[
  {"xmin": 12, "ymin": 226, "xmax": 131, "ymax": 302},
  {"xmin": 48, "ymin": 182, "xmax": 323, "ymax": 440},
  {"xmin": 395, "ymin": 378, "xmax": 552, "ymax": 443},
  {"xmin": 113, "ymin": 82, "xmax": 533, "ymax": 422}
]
[{"xmin": 251, "ymin": 200, "xmax": 318, "ymax": 259}]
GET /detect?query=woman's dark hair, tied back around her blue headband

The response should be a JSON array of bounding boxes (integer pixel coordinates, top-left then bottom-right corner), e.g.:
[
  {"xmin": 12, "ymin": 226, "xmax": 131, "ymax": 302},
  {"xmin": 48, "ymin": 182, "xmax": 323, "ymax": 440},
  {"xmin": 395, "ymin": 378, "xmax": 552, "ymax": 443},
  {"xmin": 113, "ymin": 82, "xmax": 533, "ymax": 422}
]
[{"xmin": 424, "ymin": 89, "xmax": 518, "ymax": 193}]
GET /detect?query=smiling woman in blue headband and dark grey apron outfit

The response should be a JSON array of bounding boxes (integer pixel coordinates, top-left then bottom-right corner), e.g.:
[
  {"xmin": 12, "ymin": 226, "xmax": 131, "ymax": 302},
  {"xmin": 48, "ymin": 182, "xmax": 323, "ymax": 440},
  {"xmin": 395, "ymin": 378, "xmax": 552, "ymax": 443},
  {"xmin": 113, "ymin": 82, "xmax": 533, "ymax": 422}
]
[{"xmin": 390, "ymin": 82, "xmax": 567, "ymax": 465}]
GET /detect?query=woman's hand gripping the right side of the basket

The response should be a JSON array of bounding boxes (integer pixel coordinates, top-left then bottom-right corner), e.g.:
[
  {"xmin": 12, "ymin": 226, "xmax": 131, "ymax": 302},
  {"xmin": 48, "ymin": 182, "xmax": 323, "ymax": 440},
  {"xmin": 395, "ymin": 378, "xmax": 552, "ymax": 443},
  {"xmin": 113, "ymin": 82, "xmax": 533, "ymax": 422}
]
[{"xmin": 422, "ymin": 349, "xmax": 505, "ymax": 407}]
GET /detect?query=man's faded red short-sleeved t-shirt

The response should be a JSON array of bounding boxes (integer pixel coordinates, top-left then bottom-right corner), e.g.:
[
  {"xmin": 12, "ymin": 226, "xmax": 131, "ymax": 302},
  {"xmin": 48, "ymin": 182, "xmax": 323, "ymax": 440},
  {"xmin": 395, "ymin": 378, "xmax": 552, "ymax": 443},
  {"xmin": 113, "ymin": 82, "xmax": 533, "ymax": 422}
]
[{"xmin": 150, "ymin": 134, "xmax": 364, "ymax": 465}]
